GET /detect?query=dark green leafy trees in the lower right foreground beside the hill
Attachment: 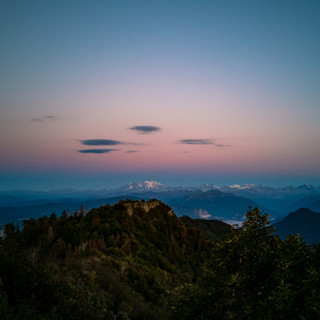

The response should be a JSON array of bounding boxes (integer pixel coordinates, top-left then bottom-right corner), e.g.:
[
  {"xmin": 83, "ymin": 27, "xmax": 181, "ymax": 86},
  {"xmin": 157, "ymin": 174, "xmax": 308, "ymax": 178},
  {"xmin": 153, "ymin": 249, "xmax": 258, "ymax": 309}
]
[{"xmin": 173, "ymin": 208, "xmax": 320, "ymax": 319}]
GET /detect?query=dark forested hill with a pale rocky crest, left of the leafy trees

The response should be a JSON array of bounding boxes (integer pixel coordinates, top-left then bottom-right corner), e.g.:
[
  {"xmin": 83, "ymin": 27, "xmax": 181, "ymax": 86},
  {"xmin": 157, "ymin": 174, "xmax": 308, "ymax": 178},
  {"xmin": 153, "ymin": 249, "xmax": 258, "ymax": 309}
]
[{"xmin": 0, "ymin": 200, "xmax": 231, "ymax": 319}]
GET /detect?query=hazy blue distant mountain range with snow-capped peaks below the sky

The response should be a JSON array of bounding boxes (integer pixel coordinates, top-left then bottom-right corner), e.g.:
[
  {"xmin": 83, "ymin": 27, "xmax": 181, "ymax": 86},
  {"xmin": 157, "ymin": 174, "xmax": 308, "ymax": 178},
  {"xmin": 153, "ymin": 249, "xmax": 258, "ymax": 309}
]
[{"xmin": 0, "ymin": 181, "xmax": 320, "ymax": 241}]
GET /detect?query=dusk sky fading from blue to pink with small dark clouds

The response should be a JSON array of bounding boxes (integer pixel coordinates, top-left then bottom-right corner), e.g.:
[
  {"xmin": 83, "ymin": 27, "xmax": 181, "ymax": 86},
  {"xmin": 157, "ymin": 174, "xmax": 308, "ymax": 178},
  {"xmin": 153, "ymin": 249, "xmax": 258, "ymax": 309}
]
[{"xmin": 0, "ymin": 0, "xmax": 320, "ymax": 190}]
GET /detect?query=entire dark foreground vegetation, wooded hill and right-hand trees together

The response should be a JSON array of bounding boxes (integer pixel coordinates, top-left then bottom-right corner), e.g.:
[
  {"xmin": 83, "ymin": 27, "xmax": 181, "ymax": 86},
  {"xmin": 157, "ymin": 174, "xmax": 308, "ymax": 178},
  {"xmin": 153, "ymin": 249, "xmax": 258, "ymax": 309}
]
[{"xmin": 0, "ymin": 200, "xmax": 320, "ymax": 320}]
